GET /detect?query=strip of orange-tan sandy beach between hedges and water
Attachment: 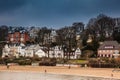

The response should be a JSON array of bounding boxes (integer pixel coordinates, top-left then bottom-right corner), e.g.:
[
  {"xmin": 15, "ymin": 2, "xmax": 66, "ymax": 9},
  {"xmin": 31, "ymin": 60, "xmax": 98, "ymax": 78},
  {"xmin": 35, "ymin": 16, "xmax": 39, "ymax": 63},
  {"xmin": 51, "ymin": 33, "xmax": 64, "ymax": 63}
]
[{"xmin": 0, "ymin": 66, "xmax": 120, "ymax": 79}]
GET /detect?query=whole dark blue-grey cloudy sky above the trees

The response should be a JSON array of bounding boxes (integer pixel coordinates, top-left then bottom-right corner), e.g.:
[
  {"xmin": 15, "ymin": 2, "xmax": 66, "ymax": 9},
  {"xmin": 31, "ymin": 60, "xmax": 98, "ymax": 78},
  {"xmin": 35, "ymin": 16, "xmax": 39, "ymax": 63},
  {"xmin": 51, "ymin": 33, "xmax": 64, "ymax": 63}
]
[{"xmin": 0, "ymin": 0, "xmax": 120, "ymax": 28}]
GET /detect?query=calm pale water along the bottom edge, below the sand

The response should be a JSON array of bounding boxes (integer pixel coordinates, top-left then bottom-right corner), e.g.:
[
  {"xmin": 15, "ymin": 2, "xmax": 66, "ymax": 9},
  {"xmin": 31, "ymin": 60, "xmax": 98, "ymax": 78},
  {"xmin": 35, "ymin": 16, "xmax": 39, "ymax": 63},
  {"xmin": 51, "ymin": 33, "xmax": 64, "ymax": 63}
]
[{"xmin": 0, "ymin": 71, "xmax": 120, "ymax": 80}]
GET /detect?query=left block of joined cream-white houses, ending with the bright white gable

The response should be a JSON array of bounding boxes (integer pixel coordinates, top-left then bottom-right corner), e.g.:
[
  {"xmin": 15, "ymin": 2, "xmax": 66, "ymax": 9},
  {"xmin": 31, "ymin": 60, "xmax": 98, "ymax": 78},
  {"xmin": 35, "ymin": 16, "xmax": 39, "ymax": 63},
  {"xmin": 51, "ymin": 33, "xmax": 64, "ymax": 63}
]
[{"xmin": 2, "ymin": 44, "xmax": 45, "ymax": 57}]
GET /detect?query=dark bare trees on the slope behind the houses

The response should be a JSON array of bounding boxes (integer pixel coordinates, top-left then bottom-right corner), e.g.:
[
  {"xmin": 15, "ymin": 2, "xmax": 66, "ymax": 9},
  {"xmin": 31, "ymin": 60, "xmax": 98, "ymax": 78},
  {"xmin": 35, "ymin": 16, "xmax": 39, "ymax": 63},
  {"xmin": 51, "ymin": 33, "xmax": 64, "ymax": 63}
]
[{"xmin": 0, "ymin": 14, "xmax": 120, "ymax": 57}]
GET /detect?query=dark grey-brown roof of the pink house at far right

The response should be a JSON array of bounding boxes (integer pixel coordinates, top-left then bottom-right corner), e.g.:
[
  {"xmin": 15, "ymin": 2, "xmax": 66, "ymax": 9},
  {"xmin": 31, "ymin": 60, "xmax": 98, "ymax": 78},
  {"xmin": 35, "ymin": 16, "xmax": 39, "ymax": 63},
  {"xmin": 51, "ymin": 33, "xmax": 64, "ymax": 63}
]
[{"xmin": 98, "ymin": 41, "xmax": 120, "ymax": 50}]
